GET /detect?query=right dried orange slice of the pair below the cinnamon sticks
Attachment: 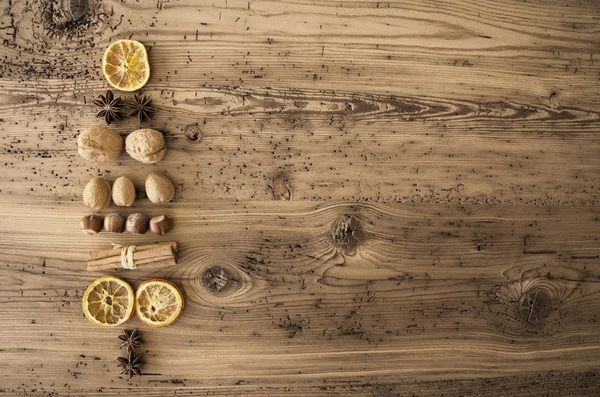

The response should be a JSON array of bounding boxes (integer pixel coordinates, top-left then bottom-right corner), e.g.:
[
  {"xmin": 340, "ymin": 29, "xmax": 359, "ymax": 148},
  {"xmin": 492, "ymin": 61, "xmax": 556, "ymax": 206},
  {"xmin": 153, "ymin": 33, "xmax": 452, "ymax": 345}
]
[{"xmin": 135, "ymin": 278, "xmax": 183, "ymax": 328}]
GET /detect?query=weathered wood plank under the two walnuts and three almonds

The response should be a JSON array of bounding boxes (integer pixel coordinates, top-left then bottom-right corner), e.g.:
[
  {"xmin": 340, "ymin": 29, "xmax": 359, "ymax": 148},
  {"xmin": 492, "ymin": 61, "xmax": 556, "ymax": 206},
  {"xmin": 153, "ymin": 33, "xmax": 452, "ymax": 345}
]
[{"xmin": 0, "ymin": 83, "xmax": 600, "ymax": 205}]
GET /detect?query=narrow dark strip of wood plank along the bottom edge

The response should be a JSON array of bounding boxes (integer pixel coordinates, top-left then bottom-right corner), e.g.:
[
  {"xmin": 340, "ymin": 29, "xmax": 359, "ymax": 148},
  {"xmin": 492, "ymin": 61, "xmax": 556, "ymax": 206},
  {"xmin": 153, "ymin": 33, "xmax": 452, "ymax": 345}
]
[{"xmin": 0, "ymin": 372, "xmax": 600, "ymax": 397}]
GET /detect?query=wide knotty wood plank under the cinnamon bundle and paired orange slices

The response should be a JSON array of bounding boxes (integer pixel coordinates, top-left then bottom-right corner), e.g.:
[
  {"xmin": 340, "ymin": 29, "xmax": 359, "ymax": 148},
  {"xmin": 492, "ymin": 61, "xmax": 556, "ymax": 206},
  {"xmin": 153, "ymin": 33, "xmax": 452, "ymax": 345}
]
[{"xmin": 0, "ymin": 202, "xmax": 600, "ymax": 393}]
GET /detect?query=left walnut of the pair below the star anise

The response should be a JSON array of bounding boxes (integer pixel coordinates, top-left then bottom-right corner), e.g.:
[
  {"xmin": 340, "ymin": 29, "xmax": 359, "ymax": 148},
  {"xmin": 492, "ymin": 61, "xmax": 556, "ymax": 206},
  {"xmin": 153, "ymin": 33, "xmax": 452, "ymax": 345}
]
[{"xmin": 77, "ymin": 127, "xmax": 123, "ymax": 163}]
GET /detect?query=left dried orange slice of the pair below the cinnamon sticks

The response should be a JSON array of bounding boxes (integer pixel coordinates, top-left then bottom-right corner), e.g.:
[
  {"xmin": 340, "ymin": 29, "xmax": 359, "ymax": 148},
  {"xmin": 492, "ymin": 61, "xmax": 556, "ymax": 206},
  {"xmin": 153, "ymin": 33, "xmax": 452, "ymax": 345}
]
[{"xmin": 83, "ymin": 276, "xmax": 135, "ymax": 327}]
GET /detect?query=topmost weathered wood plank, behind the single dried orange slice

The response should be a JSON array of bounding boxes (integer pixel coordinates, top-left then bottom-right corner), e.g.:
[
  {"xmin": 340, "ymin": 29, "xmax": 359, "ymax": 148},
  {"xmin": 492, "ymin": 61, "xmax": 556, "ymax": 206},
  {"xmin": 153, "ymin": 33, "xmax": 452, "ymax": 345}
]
[{"xmin": 3, "ymin": 0, "xmax": 600, "ymax": 89}]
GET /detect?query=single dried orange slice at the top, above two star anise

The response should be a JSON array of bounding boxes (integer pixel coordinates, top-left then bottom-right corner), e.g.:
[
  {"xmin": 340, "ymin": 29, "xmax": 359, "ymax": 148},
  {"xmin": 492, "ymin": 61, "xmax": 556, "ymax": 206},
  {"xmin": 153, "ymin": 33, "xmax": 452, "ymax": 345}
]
[{"xmin": 102, "ymin": 40, "xmax": 150, "ymax": 91}]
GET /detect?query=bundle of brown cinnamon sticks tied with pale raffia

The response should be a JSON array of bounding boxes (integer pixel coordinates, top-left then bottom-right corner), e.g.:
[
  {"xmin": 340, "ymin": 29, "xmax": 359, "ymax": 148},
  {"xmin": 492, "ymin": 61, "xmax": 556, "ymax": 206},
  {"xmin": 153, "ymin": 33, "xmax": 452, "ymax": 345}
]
[{"xmin": 87, "ymin": 241, "xmax": 177, "ymax": 272}]
